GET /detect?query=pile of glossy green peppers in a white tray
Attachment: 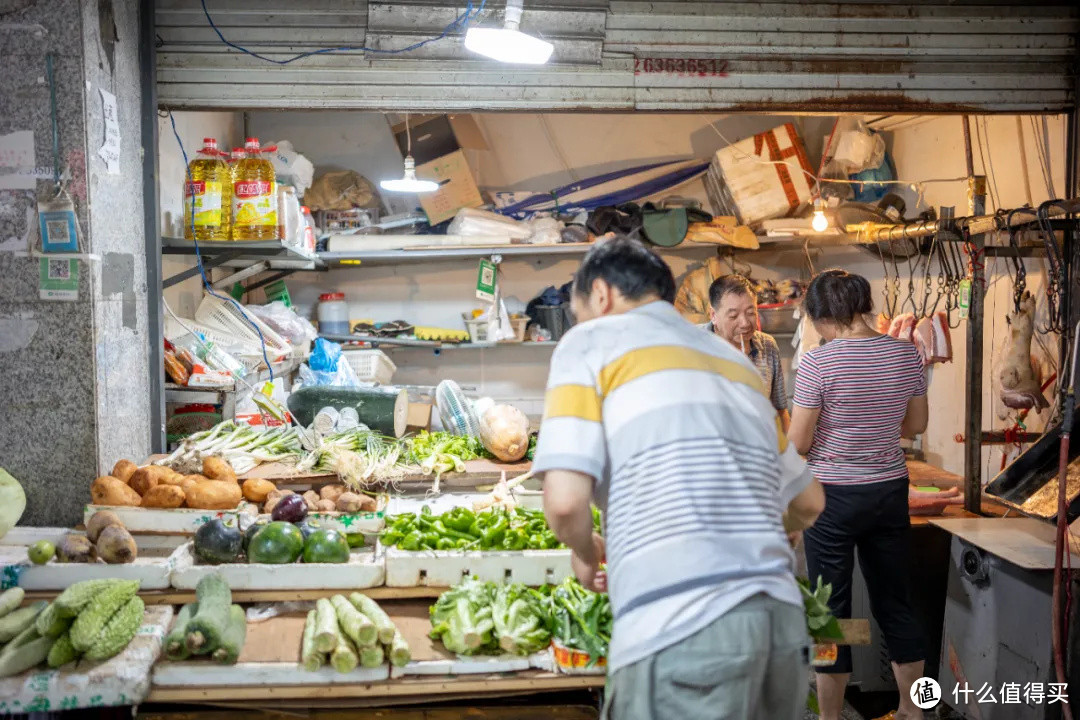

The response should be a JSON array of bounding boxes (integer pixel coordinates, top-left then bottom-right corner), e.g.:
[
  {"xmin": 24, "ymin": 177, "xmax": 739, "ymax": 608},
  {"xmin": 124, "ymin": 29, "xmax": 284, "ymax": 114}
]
[{"xmin": 379, "ymin": 505, "xmax": 564, "ymax": 551}]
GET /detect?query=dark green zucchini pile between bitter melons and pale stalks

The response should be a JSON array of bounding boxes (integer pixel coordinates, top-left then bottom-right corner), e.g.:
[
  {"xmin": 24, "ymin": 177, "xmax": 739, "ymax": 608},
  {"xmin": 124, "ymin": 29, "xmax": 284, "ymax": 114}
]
[{"xmin": 165, "ymin": 573, "xmax": 247, "ymax": 665}]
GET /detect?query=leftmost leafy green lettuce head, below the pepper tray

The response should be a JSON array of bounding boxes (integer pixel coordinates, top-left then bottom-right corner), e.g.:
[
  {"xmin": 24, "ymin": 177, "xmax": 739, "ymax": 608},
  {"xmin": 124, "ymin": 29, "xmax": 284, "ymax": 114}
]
[{"xmin": 431, "ymin": 578, "xmax": 496, "ymax": 655}]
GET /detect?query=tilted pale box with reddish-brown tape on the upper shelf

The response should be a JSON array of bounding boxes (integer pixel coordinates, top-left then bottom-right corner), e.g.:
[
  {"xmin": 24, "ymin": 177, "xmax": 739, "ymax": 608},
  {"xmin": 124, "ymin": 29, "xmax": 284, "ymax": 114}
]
[{"xmin": 705, "ymin": 123, "xmax": 813, "ymax": 225}]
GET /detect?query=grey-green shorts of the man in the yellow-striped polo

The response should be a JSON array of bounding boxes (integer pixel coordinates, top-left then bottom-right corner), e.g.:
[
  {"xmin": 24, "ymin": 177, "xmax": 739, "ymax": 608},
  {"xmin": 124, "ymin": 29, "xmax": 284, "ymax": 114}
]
[{"xmin": 600, "ymin": 595, "xmax": 810, "ymax": 720}]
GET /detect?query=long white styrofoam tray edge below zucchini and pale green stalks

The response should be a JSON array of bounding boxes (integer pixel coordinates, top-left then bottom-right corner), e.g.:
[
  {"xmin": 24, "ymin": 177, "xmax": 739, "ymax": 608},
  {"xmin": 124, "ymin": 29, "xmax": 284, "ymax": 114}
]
[{"xmin": 153, "ymin": 661, "xmax": 390, "ymax": 688}]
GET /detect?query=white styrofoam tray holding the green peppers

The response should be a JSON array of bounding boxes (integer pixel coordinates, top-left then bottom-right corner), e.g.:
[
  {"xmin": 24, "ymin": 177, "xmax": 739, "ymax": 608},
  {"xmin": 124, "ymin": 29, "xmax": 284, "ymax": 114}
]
[{"xmin": 379, "ymin": 544, "xmax": 573, "ymax": 587}]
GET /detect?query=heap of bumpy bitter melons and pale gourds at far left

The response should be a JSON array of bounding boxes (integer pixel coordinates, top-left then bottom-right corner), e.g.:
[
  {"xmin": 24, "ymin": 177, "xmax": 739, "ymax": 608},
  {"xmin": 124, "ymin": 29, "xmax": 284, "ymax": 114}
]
[{"xmin": 0, "ymin": 580, "xmax": 144, "ymax": 678}]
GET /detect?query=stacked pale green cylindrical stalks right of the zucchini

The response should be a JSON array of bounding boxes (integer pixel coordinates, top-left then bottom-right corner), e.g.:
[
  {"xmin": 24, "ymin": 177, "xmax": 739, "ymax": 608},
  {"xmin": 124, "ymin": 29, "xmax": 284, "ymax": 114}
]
[{"xmin": 300, "ymin": 593, "xmax": 413, "ymax": 673}]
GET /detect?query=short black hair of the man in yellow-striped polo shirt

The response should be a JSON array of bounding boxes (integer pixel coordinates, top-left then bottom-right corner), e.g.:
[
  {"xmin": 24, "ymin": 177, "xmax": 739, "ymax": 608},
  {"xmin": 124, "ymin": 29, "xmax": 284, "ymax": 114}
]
[{"xmin": 573, "ymin": 235, "xmax": 675, "ymax": 302}]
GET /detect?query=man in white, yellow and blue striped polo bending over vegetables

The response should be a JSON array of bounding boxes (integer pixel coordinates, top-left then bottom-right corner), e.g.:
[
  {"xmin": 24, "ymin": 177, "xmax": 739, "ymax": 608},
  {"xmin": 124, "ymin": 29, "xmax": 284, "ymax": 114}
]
[{"xmin": 534, "ymin": 237, "xmax": 824, "ymax": 720}]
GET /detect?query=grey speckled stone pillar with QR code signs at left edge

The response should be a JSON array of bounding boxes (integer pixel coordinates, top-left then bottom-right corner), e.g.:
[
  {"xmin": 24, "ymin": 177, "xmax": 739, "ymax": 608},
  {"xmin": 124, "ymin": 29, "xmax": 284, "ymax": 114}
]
[{"xmin": 0, "ymin": 0, "xmax": 157, "ymax": 526}]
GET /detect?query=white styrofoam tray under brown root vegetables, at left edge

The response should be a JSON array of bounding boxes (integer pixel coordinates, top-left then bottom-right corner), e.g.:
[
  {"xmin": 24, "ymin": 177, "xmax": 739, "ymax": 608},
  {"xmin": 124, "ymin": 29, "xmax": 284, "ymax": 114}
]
[{"xmin": 0, "ymin": 528, "xmax": 172, "ymax": 590}]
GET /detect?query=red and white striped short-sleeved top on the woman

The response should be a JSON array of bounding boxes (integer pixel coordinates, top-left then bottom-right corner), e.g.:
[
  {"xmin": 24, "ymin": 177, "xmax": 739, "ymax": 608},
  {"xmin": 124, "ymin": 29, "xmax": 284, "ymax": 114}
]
[{"xmin": 793, "ymin": 335, "xmax": 927, "ymax": 485}]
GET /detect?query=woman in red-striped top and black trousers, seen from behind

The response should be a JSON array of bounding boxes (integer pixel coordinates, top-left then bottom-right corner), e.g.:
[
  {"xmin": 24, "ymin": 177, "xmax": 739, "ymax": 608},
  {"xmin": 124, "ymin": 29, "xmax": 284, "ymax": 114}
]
[{"xmin": 789, "ymin": 270, "xmax": 928, "ymax": 720}]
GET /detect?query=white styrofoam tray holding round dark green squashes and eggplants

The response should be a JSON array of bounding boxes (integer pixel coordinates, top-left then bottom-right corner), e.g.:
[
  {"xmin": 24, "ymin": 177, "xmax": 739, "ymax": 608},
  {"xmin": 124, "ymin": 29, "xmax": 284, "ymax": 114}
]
[{"xmin": 171, "ymin": 543, "xmax": 386, "ymax": 590}]
